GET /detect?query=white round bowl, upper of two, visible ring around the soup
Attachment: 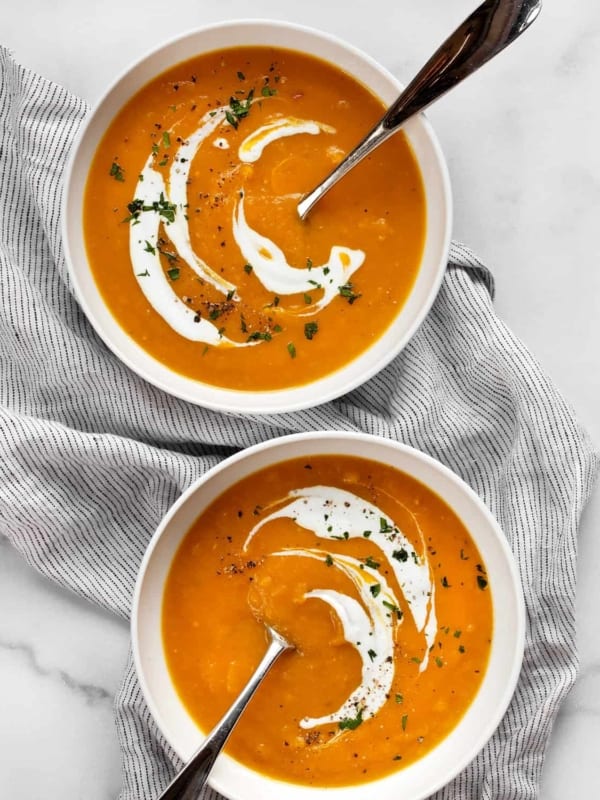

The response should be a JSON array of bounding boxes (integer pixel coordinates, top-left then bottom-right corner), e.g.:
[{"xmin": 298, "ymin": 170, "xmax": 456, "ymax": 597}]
[{"xmin": 63, "ymin": 20, "xmax": 452, "ymax": 413}]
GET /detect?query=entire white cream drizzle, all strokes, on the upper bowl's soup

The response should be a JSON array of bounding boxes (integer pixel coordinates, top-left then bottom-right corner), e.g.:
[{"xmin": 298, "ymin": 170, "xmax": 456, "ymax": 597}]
[{"xmin": 129, "ymin": 106, "xmax": 365, "ymax": 340}]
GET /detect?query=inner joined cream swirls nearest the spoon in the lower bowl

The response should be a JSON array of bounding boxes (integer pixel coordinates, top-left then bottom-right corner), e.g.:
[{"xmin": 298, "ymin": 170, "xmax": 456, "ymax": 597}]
[{"xmin": 272, "ymin": 548, "xmax": 399, "ymax": 728}]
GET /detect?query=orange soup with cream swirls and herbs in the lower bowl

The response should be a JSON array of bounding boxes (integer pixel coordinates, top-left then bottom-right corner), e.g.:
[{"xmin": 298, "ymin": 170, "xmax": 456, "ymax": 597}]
[{"xmin": 163, "ymin": 456, "xmax": 493, "ymax": 786}]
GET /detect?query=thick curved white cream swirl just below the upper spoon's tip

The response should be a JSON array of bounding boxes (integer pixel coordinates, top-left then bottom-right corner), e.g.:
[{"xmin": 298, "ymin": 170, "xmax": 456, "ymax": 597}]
[{"xmin": 233, "ymin": 195, "xmax": 365, "ymax": 314}]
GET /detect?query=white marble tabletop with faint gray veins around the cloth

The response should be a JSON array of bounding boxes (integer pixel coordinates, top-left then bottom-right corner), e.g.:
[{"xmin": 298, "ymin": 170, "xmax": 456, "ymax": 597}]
[{"xmin": 0, "ymin": 0, "xmax": 600, "ymax": 800}]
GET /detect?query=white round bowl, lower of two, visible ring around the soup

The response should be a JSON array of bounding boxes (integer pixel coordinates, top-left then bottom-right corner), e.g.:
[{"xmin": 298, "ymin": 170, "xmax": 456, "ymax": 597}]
[{"xmin": 131, "ymin": 432, "xmax": 525, "ymax": 800}]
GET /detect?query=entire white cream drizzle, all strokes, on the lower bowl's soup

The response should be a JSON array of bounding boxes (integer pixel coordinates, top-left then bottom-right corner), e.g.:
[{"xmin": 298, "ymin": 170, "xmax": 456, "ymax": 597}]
[{"xmin": 244, "ymin": 486, "xmax": 437, "ymax": 727}]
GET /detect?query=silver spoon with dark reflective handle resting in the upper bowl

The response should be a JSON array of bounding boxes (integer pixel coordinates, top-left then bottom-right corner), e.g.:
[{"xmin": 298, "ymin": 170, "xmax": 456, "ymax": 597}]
[{"xmin": 298, "ymin": 0, "xmax": 542, "ymax": 219}]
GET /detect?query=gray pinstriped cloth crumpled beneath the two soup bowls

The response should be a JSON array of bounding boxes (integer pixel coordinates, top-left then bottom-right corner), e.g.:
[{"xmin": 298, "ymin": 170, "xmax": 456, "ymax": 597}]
[{"xmin": 0, "ymin": 49, "xmax": 598, "ymax": 800}]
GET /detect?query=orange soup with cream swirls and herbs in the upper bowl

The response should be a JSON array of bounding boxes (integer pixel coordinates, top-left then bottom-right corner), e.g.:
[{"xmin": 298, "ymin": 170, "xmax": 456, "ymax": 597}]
[{"xmin": 83, "ymin": 47, "xmax": 426, "ymax": 390}]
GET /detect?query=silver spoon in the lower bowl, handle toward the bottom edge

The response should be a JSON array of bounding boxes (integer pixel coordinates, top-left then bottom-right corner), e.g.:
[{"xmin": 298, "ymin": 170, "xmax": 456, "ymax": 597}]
[{"xmin": 158, "ymin": 625, "xmax": 293, "ymax": 800}]
